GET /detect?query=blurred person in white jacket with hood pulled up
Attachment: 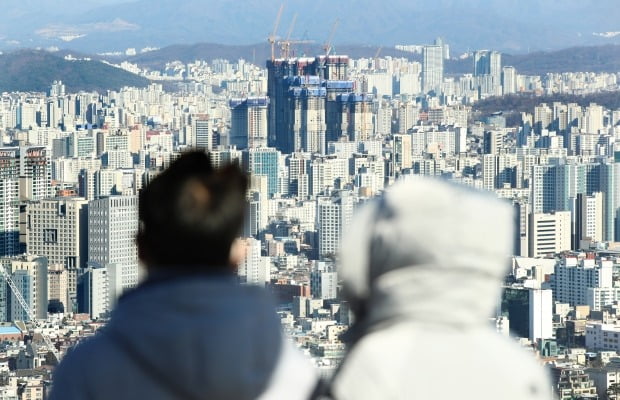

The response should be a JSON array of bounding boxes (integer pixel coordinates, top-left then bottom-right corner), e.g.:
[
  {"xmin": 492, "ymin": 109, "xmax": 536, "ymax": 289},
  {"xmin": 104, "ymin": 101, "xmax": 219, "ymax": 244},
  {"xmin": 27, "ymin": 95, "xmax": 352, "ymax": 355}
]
[{"xmin": 330, "ymin": 178, "xmax": 553, "ymax": 400}]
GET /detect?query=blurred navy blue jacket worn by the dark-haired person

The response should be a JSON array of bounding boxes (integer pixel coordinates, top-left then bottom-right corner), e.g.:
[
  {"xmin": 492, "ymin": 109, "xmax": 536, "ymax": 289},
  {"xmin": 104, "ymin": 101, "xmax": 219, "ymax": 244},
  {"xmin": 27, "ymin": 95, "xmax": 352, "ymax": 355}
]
[{"xmin": 50, "ymin": 276, "xmax": 316, "ymax": 400}]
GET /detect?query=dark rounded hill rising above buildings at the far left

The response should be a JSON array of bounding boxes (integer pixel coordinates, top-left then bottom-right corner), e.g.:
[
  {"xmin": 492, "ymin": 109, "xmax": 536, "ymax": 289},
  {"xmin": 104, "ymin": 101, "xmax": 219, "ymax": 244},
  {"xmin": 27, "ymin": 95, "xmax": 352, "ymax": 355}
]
[{"xmin": 0, "ymin": 50, "xmax": 149, "ymax": 92}]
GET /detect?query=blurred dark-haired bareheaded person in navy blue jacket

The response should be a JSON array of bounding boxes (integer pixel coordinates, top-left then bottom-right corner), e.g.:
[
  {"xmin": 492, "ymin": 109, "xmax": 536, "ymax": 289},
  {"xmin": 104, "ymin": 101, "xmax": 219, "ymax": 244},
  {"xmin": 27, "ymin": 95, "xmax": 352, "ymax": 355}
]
[{"xmin": 50, "ymin": 152, "xmax": 317, "ymax": 400}]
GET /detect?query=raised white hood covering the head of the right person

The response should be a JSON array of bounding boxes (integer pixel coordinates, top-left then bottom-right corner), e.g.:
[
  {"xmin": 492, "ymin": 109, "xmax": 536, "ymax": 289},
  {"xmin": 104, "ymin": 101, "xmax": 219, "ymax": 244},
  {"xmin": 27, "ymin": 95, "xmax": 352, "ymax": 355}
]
[{"xmin": 340, "ymin": 177, "xmax": 514, "ymax": 336}]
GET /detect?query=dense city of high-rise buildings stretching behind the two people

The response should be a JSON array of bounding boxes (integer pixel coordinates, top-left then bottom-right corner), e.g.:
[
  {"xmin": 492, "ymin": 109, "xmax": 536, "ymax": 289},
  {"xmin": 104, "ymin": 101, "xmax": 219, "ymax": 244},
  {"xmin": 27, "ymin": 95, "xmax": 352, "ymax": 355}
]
[{"xmin": 0, "ymin": 20, "xmax": 620, "ymax": 399}]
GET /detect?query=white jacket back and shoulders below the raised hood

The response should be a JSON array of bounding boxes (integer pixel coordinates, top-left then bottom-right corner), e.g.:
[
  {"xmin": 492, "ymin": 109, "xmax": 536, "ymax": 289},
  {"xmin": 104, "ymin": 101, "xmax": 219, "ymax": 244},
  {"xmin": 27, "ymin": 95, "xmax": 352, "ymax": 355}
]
[{"xmin": 331, "ymin": 327, "xmax": 551, "ymax": 400}]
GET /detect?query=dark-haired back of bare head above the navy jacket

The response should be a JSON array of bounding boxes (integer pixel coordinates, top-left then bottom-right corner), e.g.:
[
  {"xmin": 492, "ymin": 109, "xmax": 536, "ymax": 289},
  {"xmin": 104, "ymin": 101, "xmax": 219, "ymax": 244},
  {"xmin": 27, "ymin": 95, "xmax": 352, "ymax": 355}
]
[{"xmin": 137, "ymin": 151, "xmax": 247, "ymax": 270}]
